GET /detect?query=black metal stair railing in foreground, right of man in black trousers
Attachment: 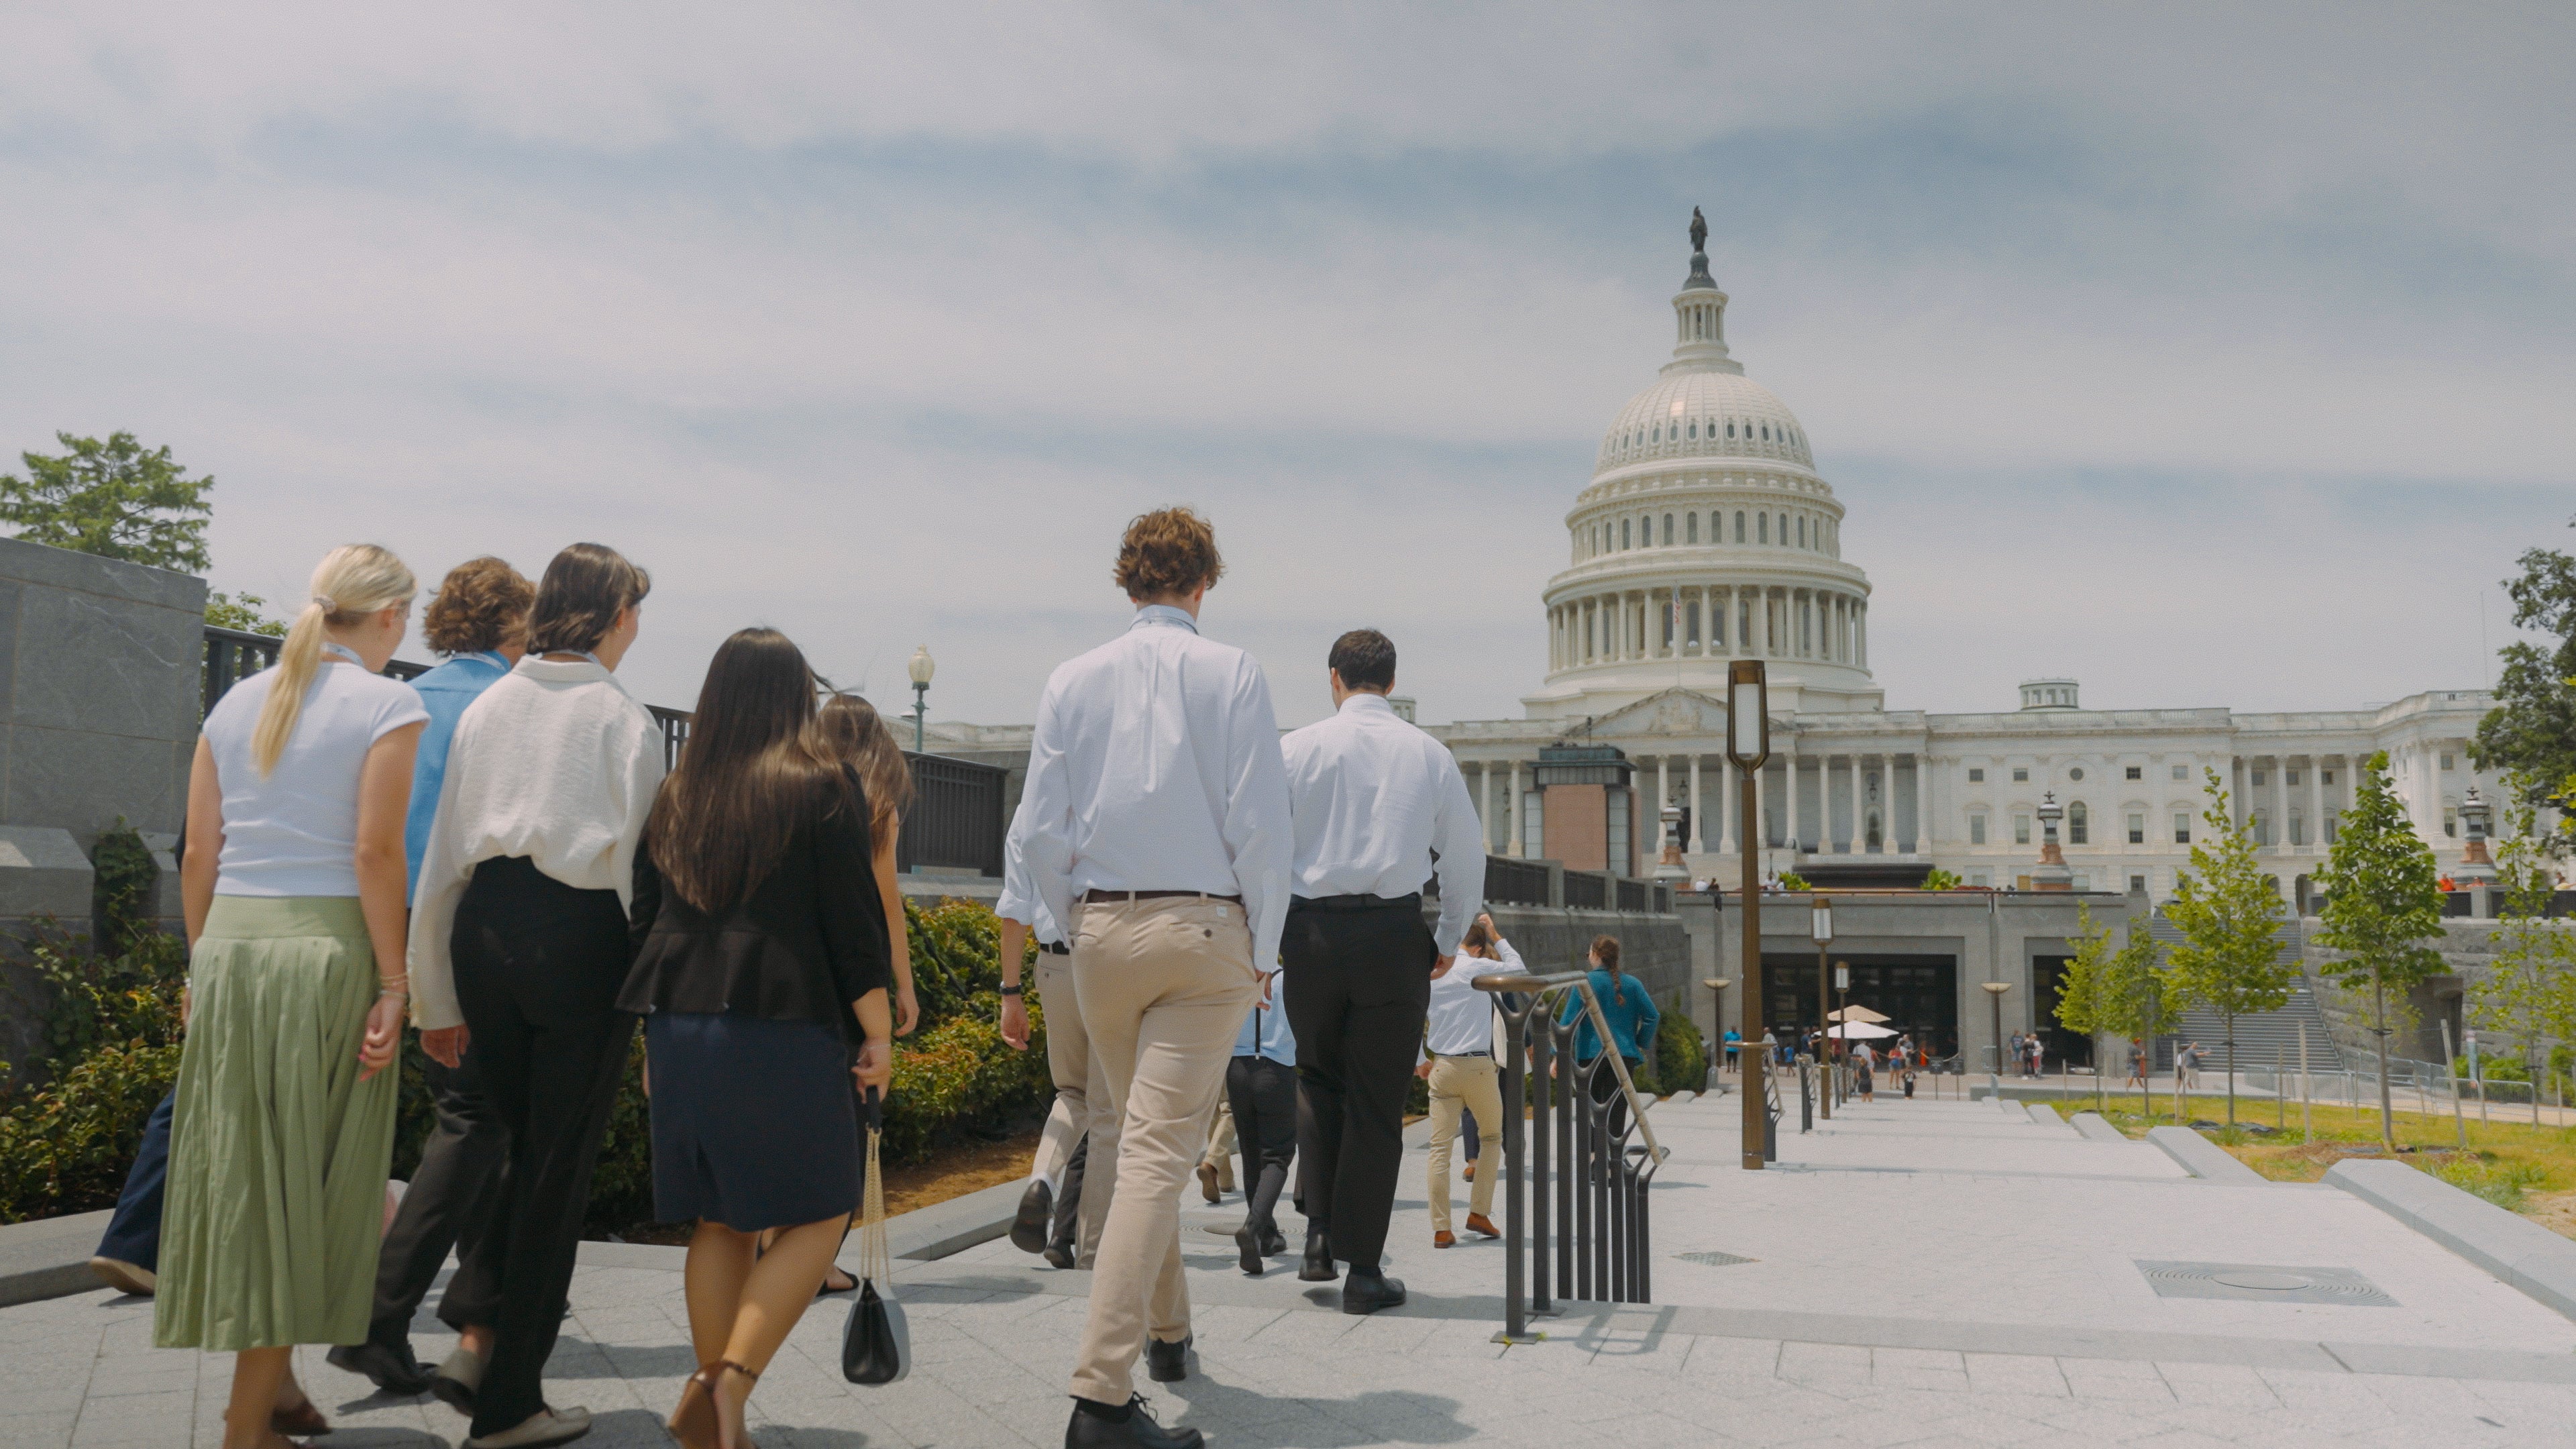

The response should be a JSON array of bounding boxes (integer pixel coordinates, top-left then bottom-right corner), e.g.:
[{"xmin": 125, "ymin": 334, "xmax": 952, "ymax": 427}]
[{"xmin": 1476, "ymin": 964, "xmax": 1664, "ymax": 1343}]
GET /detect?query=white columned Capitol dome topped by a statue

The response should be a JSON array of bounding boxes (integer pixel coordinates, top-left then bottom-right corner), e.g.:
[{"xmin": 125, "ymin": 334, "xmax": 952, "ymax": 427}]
[{"xmin": 1522, "ymin": 217, "xmax": 1883, "ymax": 719}]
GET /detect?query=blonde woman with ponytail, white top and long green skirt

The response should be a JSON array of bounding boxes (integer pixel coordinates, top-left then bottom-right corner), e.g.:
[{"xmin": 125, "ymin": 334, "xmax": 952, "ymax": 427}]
[{"xmin": 152, "ymin": 544, "xmax": 427, "ymax": 1449}]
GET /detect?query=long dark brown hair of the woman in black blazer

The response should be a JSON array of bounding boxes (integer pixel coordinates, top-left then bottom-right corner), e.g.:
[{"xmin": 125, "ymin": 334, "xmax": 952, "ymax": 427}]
[{"xmin": 644, "ymin": 629, "xmax": 861, "ymax": 913}]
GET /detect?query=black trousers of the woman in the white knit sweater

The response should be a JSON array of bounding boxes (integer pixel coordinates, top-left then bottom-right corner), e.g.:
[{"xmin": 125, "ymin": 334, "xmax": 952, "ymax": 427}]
[{"xmin": 451, "ymin": 856, "xmax": 636, "ymax": 1436}]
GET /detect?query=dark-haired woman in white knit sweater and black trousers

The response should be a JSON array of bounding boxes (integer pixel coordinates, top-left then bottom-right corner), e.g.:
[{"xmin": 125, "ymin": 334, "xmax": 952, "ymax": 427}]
[{"xmin": 412, "ymin": 544, "xmax": 662, "ymax": 1449}]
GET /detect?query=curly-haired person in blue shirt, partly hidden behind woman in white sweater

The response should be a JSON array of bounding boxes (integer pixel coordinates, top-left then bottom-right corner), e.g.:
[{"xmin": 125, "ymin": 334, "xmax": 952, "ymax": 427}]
[{"xmin": 330, "ymin": 557, "xmax": 536, "ymax": 1395}]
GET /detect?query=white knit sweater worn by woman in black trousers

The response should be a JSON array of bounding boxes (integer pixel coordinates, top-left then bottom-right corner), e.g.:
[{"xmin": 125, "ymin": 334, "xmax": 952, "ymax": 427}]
[{"xmin": 410, "ymin": 657, "xmax": 662, "ymax": 1031}]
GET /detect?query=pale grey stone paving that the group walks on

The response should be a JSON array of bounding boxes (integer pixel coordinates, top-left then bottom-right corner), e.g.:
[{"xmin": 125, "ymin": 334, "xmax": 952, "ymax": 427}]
[{"xmin": 0, "ymin": 1098, "xmax": 2576, "ymax": 1449}]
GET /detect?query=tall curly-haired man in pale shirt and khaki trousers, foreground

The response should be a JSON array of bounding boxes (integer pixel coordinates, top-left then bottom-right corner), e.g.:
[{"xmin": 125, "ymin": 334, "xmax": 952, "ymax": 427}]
[{"xmin": 1010, "ymin": 508, "xmax": 1291, "ymax": 1449}]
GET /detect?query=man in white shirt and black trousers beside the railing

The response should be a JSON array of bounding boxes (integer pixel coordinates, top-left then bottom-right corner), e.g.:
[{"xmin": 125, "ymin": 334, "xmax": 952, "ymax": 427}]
[{"xmin": 1280, "ymin": 629, "xmax": 1484, "ymax": 1312}]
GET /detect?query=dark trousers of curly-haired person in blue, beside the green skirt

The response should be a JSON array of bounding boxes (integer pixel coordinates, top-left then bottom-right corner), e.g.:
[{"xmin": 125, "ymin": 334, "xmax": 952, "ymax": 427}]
[{"xmin": 366, "ymin": 1042, "xmax": 510, "ymax": 1348}]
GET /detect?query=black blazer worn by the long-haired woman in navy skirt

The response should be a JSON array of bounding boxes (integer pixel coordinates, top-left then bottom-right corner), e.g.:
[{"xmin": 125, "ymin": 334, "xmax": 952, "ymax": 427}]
[{"xmin": 619, "ymin": 773, "xmax": 894, "ymax": 1026}]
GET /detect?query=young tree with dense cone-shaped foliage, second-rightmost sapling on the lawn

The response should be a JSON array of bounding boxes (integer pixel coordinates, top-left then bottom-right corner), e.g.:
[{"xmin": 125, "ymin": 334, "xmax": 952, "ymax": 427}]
[{"xmin": 2316, "ymin": 750, "xmax": 2445, "ymax": 1152}]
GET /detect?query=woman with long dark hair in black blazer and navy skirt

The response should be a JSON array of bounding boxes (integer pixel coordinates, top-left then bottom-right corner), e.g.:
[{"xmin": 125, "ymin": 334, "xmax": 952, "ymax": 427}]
[{"xmin": 619, "ymin": 629, "xmax": 894, "ymax": 1449}]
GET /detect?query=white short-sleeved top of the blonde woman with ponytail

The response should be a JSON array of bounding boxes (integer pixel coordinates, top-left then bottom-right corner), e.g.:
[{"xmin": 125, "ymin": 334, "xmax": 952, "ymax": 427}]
[{"xmin": 203, "ymin": 655, "xmax": 430, "ymax": 895}]
